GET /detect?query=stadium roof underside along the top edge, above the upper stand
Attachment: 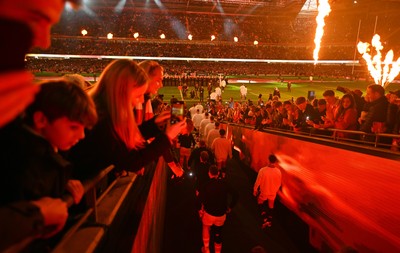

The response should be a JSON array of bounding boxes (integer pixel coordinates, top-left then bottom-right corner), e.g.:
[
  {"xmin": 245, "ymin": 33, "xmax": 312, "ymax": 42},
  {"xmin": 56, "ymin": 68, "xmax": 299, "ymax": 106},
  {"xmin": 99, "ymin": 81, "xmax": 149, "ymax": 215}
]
[{"xmin": 83, "ymin": 0, "xmax": 400, "ymax": 17}]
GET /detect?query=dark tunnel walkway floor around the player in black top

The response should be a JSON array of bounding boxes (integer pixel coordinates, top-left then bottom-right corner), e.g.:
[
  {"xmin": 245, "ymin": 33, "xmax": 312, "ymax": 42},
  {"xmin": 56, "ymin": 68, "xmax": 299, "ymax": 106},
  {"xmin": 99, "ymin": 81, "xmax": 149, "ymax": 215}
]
[{"xmin": 162, "ymin": 159, "xmax": 316, "ymax": 253}]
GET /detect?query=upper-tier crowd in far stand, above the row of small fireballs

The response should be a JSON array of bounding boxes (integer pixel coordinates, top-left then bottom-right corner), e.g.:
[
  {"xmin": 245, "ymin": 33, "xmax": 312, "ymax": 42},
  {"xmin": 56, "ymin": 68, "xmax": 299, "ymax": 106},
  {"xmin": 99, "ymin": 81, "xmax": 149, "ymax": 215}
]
[{"xmin": 53, "ymin": 7, "xmax": 398, "ymax": 45}]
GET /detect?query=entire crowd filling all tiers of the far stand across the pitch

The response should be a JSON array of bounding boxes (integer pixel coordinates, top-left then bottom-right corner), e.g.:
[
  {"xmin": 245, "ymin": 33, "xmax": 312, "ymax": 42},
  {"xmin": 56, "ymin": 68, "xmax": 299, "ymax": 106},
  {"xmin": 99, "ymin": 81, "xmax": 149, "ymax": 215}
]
[{"xmin": 28, "ymin": 3, "xmax": 400, "ymax": 78}]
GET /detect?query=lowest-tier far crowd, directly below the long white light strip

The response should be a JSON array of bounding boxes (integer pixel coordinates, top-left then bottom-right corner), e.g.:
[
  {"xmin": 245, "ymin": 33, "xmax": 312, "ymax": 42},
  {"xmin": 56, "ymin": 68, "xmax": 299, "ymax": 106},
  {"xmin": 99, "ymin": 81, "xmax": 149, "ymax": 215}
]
[{"xmin": 26, "ymin": 58, "xmax": 368, "ymax": 78}]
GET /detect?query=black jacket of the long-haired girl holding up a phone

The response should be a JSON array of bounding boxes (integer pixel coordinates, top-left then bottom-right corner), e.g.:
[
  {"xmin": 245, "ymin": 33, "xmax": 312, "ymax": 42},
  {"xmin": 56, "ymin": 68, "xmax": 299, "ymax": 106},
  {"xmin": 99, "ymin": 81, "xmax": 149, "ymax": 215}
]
[{"xmin": 68, "ymin": 114, "xmax": 171, "ymax": 180}]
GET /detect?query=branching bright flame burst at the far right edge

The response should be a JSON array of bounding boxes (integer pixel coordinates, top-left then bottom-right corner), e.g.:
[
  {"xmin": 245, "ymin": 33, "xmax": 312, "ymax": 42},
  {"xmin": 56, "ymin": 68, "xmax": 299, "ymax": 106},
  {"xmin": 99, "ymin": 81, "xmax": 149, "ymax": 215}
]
[{"xmin": 357, "ymin": 34, "xmax": 400, "ymax": 87}]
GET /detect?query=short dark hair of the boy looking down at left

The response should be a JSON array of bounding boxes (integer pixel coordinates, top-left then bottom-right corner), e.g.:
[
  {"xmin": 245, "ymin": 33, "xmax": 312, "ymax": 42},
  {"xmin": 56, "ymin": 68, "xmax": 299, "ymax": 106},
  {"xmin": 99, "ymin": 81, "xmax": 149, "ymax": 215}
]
[{"xmin": 25, "ymin": 80, "xmax": 97, "ymax": 128}]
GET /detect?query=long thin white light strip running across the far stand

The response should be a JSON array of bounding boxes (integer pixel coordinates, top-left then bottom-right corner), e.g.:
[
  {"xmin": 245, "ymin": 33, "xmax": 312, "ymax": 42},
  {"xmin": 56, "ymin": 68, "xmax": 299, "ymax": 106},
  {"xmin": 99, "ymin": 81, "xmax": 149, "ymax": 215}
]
[{"xmin": 26, "ymin": 54, "xmax": 359, "ymax": 65}]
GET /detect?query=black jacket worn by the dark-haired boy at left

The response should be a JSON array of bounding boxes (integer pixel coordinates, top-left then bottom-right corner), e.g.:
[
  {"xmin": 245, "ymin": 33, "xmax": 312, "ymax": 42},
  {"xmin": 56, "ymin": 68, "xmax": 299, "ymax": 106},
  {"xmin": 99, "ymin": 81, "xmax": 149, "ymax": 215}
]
[{"xmin": 0, "ymin": 119, "xmax": 71, "ymax": 205}]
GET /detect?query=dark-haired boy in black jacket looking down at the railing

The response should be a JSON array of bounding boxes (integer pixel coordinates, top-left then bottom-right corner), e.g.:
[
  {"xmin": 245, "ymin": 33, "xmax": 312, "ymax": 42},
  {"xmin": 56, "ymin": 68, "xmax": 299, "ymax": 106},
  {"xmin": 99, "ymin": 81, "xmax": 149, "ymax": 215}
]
[{"xmin": 0, "ymin": 81, "xmax": 97, "ymax": 250}]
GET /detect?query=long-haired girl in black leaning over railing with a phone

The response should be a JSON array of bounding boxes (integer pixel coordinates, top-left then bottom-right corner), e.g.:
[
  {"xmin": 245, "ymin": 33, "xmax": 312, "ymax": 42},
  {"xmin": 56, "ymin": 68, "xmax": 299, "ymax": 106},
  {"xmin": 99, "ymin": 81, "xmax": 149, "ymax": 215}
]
[{"xmin": 71, "ymin": 59, "xmax": 186, "ymax": 178}]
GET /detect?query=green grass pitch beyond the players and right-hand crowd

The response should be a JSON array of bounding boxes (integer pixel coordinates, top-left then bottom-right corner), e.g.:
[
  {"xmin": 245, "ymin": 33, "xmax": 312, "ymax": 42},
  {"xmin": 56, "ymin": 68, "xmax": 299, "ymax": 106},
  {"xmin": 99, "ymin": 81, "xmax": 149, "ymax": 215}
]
[{"xmin": 159, "ymin": 77, "xmax": 400, "ymax": 103}]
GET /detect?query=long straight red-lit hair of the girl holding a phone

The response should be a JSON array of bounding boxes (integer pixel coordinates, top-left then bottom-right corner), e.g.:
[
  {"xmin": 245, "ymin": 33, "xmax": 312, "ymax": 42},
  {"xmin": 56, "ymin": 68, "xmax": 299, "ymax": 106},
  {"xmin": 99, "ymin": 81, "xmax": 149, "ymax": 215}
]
[{"xmin": 89, "ymin": 59, "xmax": 148, "ymax": 149}]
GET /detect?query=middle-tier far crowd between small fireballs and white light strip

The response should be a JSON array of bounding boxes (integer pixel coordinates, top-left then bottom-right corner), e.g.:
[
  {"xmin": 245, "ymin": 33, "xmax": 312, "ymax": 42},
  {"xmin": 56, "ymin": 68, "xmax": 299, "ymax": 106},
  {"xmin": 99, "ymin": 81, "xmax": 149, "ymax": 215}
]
[{"xmin": 35, "ymin": 37, "xmax": 355, "ymax": 60}]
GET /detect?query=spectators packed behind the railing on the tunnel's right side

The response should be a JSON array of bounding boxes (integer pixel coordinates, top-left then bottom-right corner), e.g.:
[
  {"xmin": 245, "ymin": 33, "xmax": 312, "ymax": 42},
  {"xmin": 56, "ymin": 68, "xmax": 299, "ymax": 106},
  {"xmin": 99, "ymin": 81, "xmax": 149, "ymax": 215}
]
[{"xmin": 184, "ymin": 85, "xmax": 400, "ymax": 150}]
